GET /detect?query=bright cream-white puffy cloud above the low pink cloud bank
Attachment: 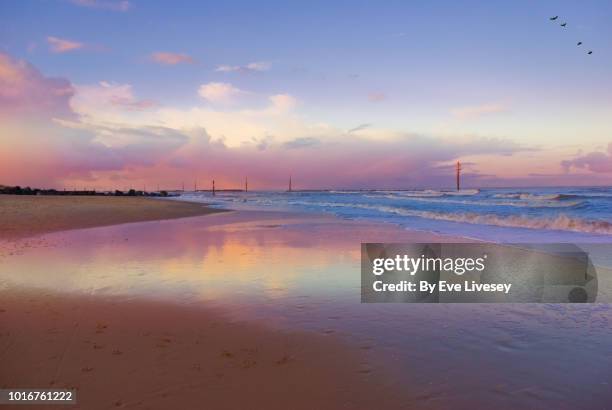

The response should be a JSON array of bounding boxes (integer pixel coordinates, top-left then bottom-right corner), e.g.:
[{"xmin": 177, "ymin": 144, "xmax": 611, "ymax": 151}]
[{"xmin": 62, "ymin": 78, "xmax": 342, "ymax": 147}]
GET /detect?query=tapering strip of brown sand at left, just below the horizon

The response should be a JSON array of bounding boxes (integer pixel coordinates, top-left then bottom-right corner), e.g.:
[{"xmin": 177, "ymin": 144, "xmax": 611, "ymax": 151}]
[{"xmin": 0, "ymin": 195, "xmax": 222, "ymax": 239}]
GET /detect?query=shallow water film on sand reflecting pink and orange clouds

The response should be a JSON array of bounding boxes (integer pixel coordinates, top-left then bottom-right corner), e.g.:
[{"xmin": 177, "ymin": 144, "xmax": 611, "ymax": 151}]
[{"xmin": 0, "ymin": 212, "xmax": 612, "ymax": 409}]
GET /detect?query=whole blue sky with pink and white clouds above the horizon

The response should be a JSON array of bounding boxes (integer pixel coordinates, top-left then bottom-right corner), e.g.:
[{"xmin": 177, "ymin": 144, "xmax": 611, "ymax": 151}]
[{"xmin": 0, "ymin": 0, "xmax": 612, "ymax": 189}]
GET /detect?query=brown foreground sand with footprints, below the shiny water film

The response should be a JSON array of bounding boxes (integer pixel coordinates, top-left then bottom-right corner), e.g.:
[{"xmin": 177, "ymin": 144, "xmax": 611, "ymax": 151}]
[{"xmin": 0, "ymin": 290, "xmax": 401, "ymax": 409}]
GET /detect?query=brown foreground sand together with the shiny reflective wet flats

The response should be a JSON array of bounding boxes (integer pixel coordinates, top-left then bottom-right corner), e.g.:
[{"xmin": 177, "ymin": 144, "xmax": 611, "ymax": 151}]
[{"xmin": 0, "ymin": 198, "xmax": 612, "ymax": 410}]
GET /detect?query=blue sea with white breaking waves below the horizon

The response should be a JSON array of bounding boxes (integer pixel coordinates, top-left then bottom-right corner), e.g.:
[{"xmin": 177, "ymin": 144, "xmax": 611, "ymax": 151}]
[{"xmin": 176, "ymin": 187, "xmax": 612, "ymax": 243}]
